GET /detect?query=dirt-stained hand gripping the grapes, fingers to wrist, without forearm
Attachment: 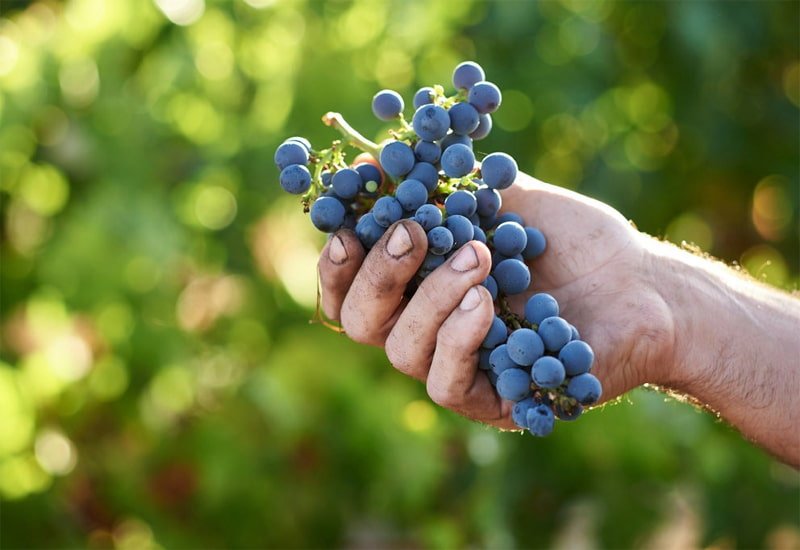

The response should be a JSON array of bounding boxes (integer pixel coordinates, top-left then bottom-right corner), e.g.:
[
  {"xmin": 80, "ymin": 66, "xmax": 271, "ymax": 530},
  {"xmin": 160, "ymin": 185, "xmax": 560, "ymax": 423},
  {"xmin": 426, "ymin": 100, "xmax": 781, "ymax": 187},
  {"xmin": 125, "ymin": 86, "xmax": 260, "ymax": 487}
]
[{"xmin": 319, "ymin": 175, "xmax": 673, "ymax": 428}]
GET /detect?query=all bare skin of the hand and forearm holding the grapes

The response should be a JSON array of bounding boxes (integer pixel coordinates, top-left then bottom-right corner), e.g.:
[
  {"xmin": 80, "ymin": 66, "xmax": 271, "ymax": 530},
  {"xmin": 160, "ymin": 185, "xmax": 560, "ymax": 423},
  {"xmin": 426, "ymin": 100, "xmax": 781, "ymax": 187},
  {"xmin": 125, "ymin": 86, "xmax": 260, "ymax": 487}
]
[{"xmin": 319, "ymin": 174, "xmax": 800, "ymax": 466}]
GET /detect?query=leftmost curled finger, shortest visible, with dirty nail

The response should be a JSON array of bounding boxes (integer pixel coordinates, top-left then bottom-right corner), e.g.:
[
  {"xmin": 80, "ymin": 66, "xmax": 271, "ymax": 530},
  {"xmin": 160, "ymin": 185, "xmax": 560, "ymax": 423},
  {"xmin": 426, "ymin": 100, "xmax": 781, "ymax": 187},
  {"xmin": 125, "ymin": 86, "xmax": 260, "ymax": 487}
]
[{"xmin": 317, "ymin": 229, "xmax": 365, "ymax": 321}]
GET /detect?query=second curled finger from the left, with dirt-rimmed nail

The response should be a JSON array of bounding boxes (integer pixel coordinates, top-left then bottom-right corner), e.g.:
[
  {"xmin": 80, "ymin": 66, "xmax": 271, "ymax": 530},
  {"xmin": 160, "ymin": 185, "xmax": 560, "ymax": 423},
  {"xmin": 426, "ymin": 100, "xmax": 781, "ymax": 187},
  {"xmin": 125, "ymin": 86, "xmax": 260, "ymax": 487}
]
[{"xmin": 341, "ymin": 220, "xmax": 428, "ymax": 346}]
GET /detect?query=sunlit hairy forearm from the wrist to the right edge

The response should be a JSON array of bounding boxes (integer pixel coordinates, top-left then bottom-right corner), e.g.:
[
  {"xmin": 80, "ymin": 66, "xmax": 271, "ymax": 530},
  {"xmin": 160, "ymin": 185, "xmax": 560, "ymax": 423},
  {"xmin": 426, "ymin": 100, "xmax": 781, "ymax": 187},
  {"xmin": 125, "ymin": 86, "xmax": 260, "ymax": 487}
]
[{"xmin": 648, "ymin": 241, "xmax": 800, "ymax": 466}]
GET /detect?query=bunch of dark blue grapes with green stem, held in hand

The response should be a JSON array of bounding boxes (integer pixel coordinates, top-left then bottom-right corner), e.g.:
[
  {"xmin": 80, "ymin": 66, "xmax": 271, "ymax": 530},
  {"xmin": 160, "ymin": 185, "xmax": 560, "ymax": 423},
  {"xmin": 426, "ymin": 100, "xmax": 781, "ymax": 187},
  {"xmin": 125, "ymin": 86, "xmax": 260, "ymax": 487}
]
[{"xmin": 275, "ymin": 61, "xmax": 602, "ymax": 436}]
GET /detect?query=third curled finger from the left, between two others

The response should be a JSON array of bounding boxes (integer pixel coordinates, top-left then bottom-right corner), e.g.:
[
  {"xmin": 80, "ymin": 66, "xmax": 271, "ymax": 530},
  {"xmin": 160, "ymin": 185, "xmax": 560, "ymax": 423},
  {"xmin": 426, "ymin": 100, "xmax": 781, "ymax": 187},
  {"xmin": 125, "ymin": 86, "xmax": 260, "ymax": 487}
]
[{"xmin": 386, "ymin": 241, "xmax": 492, "ymax": 380}]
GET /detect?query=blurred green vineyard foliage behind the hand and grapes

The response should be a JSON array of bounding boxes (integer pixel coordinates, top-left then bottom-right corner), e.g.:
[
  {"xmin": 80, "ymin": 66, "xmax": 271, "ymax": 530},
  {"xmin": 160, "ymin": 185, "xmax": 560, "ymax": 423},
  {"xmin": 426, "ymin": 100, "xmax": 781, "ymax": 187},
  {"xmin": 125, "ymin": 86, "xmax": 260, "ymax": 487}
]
[{"xmin": 0, "ymin": 0, "xmax": 800, "ymax": 549}]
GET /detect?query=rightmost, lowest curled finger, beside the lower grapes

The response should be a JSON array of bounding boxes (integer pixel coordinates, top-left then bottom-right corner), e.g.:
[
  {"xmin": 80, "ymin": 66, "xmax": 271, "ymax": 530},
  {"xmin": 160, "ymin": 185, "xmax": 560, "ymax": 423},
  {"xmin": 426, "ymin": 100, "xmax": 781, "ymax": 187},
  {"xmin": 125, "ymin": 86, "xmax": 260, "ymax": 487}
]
[{"xmin": 427, "ymin": 285, "xmax": 515, "ymax": 429}]
